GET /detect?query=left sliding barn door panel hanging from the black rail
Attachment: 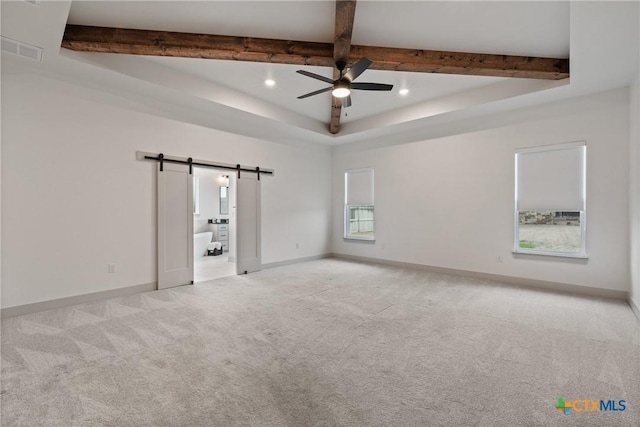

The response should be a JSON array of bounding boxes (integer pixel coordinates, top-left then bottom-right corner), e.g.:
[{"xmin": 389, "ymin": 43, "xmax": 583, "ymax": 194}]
[{"xmin": 158, "ymin": 163, "xmax": 193, "ymax": 289}]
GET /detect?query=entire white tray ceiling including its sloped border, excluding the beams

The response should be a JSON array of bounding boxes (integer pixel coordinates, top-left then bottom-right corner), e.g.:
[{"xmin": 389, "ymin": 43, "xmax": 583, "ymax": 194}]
[{"xmin": 1, "ymin": 0, "xmax": 638, "ymax": 144}]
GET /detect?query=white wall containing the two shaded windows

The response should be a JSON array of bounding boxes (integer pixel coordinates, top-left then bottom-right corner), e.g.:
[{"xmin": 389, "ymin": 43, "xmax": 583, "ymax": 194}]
[{"xmin": 332, "ymin": 88, "xmax": 629, "ymax": 292}]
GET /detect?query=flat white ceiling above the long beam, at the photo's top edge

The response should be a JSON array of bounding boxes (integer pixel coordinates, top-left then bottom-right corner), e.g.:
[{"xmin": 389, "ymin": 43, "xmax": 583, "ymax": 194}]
[{"xmin": 63, "ymin": 0, "xmax": 569, "ymax": 57}]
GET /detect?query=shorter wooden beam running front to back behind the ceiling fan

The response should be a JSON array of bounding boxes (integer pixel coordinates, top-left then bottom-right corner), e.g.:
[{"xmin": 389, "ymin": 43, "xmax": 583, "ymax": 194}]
[{"xmin": 329, "ymin": 0, "xmax": 356, "ymax": 134}]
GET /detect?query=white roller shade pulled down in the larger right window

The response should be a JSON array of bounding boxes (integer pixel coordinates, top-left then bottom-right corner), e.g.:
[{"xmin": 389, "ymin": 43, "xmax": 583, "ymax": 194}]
[{"xmin": 516, "ymin": 142, "xmax": 586, "ymax": 211}]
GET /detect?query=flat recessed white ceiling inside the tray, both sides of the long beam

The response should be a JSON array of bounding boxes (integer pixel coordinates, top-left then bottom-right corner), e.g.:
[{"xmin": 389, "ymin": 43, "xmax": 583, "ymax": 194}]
[{"xmin": 62, "ymin": 1, "xmax": 569, "ymax": 123}]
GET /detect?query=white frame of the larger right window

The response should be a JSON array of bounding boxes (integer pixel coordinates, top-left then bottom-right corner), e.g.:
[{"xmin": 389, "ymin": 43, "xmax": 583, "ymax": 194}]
[{"xmin": 512, "ymin": 141, "xmax": 588, "ymax": 259}]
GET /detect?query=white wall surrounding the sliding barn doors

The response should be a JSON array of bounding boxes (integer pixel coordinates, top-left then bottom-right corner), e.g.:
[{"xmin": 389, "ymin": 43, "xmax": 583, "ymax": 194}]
[{"xmin": 1, "ymin": 75, "xmax": 331, "ymax": 307}]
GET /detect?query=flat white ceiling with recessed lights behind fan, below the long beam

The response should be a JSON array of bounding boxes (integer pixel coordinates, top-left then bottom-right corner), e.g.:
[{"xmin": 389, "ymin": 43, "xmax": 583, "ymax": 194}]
[{"xmin": 142, "ymin": 57, "xmax": 503, "ymax": 123}]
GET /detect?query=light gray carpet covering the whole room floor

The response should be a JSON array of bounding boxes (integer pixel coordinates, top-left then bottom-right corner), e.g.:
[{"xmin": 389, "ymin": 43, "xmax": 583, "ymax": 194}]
[{"xmin": 1, "ymin": 259, "xmax": 640, "ymax": 427}]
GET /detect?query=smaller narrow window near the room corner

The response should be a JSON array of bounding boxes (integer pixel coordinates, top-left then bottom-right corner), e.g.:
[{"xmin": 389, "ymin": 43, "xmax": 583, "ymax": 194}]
[{"xmin": 344, "ymin": 169, "xmax": 374, "ymax": 240}]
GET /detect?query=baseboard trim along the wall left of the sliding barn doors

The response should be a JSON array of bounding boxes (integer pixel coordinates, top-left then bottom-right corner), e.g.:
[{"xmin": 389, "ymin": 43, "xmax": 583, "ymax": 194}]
[{"xmin": 0, "ymin": 282, "xmax": 158, "ymax": 319}]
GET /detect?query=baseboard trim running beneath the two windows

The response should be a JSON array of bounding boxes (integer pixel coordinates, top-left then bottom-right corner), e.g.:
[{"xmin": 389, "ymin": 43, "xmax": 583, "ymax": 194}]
[{"xmin": 331, "ymin": 253, "xmax": 629, "ymax": 300}]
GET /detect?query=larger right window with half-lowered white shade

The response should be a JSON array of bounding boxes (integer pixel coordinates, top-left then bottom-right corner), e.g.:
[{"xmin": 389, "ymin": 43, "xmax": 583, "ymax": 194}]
[{"xmin": 514, "ymin": 141, "xmax": 587, "ymax": 257}]
